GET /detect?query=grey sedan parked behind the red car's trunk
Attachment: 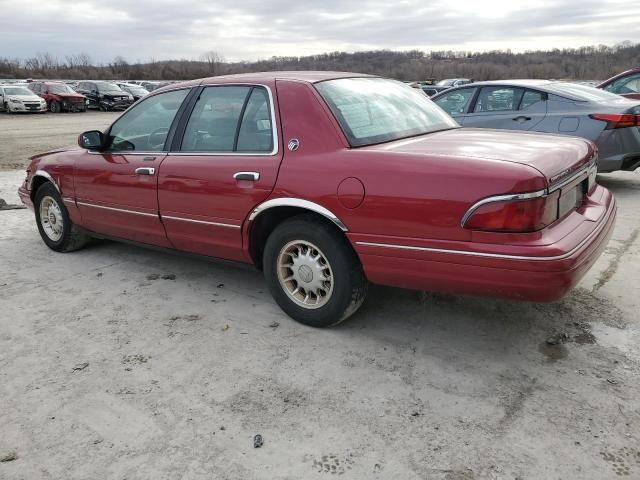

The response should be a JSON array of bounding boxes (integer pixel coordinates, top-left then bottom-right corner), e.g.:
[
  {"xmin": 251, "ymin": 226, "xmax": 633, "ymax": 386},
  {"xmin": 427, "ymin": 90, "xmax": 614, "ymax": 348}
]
[{"xmin": 432, "ymin": 80, "xmax": 640, "ymax": 172}]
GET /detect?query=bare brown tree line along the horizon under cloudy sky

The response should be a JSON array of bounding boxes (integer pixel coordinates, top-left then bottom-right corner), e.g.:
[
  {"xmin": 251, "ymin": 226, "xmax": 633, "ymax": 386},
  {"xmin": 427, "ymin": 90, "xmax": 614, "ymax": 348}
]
[{"xmin": 0, "ymin": 41, "xmax": 640, "ymax": 80}]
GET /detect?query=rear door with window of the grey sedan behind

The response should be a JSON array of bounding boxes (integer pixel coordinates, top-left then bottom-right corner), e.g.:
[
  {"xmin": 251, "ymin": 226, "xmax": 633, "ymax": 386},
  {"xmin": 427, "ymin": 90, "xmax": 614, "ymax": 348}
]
[{"xmin": 464, "ymin": 86, "xmax": 547, "ymax": 130}]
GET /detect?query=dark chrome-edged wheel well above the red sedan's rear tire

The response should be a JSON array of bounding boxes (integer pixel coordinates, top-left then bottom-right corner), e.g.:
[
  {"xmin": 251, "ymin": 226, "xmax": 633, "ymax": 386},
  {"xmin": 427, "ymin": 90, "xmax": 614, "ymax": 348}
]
[{"xmin": 249, "ymin": 206, "xmax": 344, "ymax": 270}]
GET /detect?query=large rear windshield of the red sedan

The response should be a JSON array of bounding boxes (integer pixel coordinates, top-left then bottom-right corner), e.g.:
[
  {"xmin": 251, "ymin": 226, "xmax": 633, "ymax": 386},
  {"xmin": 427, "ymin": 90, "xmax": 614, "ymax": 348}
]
[{"xmin": 315, "ymin": 78, "xmax": 459, "ymax": 147}]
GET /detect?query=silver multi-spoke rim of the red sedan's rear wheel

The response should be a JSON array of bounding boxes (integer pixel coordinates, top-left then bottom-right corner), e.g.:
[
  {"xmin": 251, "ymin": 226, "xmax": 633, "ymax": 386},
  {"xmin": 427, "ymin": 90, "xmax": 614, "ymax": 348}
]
[{"xmin": 278, "ymin": 240, "xmax": 334, "ymax": 309}]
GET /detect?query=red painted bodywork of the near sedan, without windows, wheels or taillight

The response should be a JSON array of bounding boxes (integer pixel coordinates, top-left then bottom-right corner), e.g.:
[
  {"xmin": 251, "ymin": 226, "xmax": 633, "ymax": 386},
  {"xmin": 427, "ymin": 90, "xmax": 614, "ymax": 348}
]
[{"xmin": 20, "ymin": 72, "xmax": 616, "ymax": 301}]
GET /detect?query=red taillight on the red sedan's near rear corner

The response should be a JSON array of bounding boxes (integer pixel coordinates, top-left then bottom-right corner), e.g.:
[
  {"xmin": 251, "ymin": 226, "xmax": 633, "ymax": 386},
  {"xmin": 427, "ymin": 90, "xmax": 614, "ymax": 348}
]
[{"xmin": 463, "ymin": 191, "xmax": 560, "ymax": 233}]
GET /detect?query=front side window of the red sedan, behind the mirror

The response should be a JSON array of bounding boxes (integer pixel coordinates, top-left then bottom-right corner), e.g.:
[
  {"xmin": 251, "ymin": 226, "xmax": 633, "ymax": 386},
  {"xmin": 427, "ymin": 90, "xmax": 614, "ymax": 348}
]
[{"xmin": 108, "ymin": 89, "xmax": 189, "ymax": 152}]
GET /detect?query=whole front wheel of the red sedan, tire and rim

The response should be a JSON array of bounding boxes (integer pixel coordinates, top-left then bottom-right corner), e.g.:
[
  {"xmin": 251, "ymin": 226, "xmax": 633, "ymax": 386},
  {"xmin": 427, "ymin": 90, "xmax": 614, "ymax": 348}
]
[{"xmin": 34, "ymin": 182, "xmax": 90, "ymax": 252}]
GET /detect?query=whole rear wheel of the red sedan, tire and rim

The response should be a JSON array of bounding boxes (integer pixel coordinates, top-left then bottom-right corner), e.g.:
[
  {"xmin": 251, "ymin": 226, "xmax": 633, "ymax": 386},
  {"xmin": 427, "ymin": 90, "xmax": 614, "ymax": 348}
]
[{"xmin": 263, "ymin": 215, "xmax": 367, "ymax": 327}]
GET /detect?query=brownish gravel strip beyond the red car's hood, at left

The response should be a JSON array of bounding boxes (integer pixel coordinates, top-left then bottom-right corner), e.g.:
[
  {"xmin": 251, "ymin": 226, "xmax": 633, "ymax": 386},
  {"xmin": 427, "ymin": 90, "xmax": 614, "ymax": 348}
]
[{"xmin": 0, "ymin": 110, "xmax": 120, "ymax": 170}]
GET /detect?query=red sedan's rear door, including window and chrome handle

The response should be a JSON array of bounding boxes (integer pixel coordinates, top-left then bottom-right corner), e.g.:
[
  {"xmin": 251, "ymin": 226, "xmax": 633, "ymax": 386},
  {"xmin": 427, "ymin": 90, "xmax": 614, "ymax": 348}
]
[{"xmin": 158, "ymin": 84, "xmax": 282, "ymax": 261}]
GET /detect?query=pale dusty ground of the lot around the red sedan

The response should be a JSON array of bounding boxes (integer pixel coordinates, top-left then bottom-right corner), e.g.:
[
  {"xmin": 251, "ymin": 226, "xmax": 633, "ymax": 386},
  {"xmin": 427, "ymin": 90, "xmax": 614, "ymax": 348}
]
[{"xmin": 0, "ymin": 114, "xmax": 640, "ymax": 480}]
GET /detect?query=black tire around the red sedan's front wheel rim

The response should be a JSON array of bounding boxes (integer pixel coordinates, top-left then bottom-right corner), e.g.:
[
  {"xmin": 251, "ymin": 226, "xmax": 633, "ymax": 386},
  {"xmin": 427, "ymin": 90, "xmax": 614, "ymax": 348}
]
[{"xmin": 33, "ymin": 182, "xmax": 91, "ymax": 252}]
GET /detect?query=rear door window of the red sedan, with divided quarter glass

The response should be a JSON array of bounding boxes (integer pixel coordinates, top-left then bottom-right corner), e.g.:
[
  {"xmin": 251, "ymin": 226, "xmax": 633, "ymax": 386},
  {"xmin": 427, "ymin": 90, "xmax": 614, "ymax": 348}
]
[{"xmin": 181, "ymin": 85, "xmax": 273, "ymax": 153}]
